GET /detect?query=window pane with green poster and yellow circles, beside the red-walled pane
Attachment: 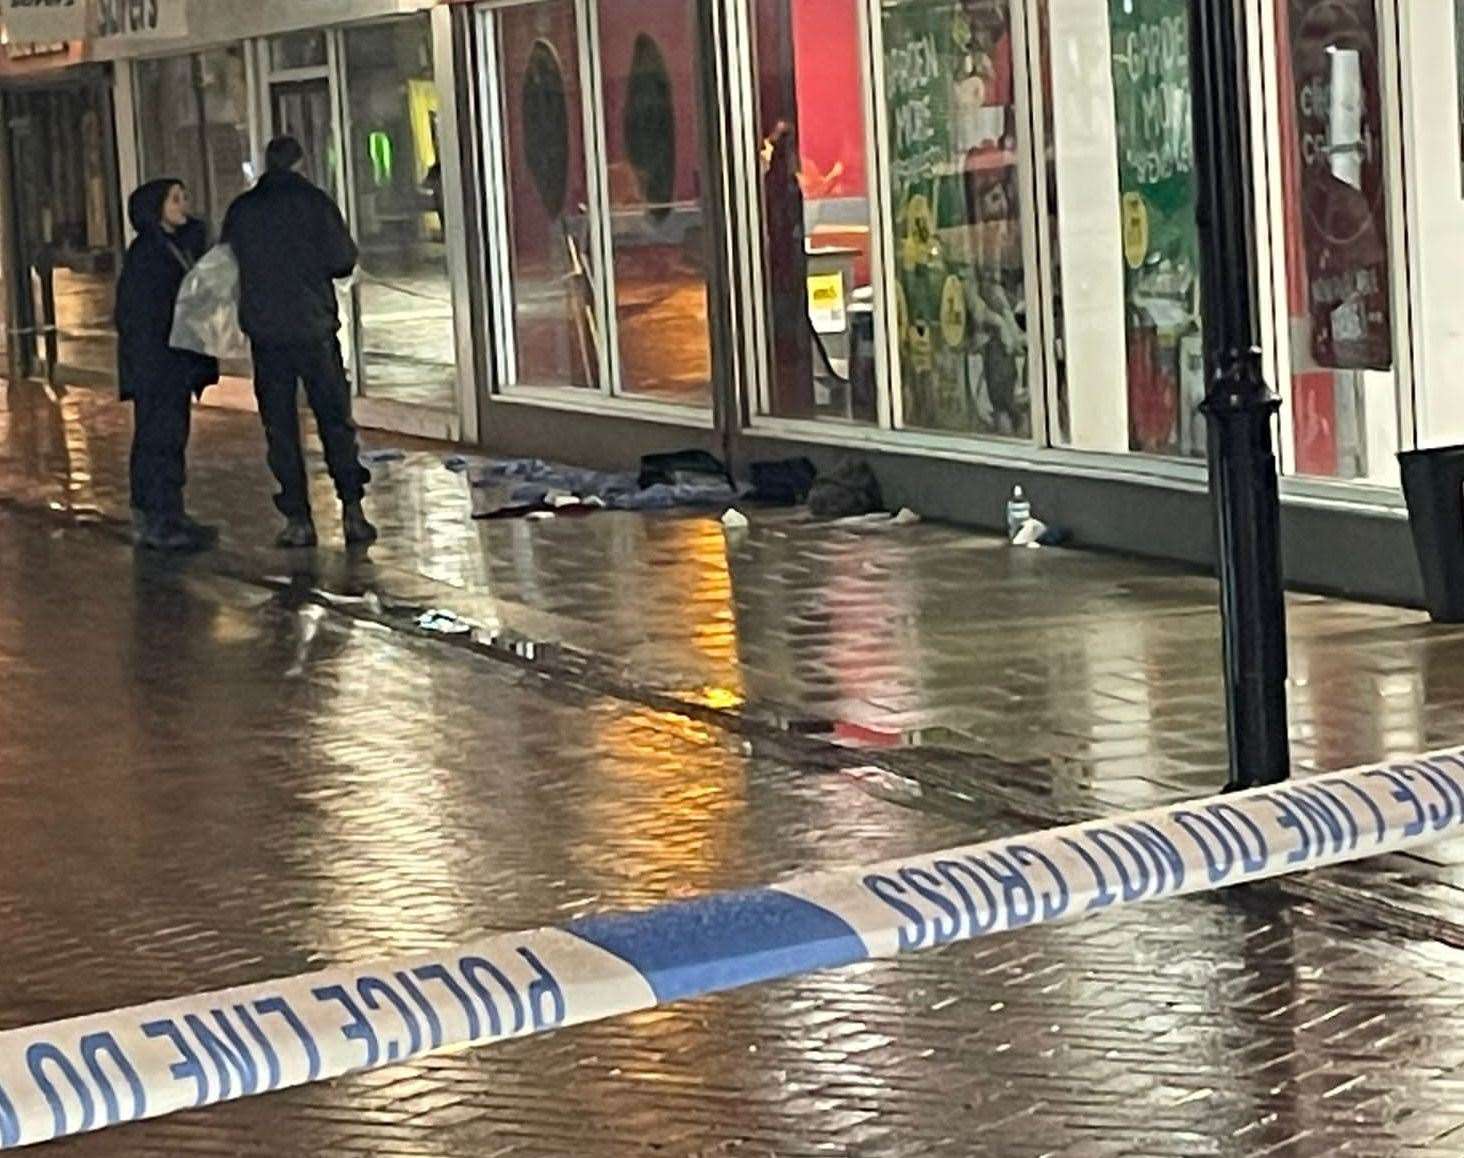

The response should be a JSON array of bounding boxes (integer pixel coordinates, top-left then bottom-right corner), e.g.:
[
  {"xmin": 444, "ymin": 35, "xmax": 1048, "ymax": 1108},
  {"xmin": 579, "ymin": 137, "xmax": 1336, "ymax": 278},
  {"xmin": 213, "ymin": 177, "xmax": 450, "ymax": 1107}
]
[{"xmin": 881, "ymin": 0, "xmax": 1032, "ymax": 438}]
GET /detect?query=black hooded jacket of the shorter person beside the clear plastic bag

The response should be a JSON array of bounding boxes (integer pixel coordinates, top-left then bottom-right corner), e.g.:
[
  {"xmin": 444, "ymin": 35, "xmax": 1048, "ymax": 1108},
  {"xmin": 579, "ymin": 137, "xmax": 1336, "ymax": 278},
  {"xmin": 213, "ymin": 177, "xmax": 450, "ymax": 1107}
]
[{"xmin": 113, "ymin": 180, "xmax": 218, "ymax": 400}]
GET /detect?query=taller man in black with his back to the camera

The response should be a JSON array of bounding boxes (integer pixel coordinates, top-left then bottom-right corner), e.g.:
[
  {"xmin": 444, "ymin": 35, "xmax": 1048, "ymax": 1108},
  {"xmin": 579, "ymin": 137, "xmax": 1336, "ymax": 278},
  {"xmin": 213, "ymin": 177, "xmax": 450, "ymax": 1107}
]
[{"xmin": 223, "ymin": 136, "xmax": 376, "ymax": 548}]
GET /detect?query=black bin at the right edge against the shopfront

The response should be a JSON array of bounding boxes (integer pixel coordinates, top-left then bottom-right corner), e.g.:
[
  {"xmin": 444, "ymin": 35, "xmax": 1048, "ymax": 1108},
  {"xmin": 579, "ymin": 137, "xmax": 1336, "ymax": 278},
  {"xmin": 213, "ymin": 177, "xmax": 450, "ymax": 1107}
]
[{"xmin": 1398, "ymin": 447, "xmax": 1464, "ymax": 624}]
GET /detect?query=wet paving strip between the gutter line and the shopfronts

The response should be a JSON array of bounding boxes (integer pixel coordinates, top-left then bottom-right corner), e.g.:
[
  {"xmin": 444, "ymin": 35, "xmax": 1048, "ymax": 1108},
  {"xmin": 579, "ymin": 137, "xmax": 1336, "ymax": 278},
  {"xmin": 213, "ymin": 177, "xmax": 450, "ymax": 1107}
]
[{"xmin": 0, "ymin": 385, "xmax": 1464, "ymax": 925}]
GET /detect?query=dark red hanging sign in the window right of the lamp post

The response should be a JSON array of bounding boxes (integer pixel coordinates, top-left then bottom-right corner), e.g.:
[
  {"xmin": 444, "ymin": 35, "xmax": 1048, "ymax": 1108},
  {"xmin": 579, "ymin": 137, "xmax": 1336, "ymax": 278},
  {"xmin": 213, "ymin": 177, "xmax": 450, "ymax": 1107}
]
[{"xmin": 1287, "ymin": 0, "xmax": 1392, "ymax": 370}]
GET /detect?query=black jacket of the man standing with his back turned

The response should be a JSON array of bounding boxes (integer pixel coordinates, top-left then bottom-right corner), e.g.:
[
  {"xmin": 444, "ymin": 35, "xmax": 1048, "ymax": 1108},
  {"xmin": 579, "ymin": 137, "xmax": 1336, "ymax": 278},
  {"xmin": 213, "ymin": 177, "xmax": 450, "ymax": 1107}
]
[{"xmin": 223, "ymin": 173, "xmax": 359, "ymax": 345}]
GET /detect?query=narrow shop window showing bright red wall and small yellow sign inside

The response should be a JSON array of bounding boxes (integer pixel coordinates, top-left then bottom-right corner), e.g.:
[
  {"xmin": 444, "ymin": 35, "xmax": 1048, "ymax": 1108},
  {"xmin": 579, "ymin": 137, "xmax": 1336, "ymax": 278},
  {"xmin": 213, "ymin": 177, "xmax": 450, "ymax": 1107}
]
[{"xmin": 754, "ymin": 0, "xmax": 878, "ymax": 423}]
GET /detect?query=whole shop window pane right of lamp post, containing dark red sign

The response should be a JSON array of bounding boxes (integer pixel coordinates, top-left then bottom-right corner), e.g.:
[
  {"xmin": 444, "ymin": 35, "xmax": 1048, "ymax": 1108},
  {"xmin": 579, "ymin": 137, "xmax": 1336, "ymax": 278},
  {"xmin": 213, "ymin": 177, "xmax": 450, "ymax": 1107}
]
[{"xmin": 1275, "ymin": 0, "xmax": 1398, "ymax": 480}]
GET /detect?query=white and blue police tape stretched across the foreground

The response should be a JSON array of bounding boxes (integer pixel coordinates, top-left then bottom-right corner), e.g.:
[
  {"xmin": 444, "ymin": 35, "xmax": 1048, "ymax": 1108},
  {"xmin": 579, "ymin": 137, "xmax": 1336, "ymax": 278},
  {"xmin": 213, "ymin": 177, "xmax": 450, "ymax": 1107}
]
[{"xmin": 0, "ymin": 748, "xmax": 1464, "ymax": 1148}]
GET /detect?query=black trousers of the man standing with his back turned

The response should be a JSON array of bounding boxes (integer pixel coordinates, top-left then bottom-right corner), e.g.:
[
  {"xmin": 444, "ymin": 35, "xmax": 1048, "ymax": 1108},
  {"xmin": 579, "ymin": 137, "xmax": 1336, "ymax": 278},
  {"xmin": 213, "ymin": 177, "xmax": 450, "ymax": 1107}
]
[{"xmin": 253, "ymin": 338, "xmax": 370, "ymax": 518}]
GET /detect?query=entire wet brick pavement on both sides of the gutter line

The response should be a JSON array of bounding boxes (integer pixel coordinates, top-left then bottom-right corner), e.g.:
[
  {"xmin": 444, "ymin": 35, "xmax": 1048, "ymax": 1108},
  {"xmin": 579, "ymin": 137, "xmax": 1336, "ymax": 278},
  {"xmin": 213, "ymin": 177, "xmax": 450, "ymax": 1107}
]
[{"xmin": 0, "ymin": 383, "xmax": 1464, "ymax": 1155}]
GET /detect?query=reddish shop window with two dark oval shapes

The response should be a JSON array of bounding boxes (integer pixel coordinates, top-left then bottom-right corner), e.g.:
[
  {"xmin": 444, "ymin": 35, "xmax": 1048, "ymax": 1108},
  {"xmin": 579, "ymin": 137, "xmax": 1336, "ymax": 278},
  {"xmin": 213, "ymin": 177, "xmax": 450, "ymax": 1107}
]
[{"xmin": 479, "ymin": 0, "xmax": 717, "ymax": 408}]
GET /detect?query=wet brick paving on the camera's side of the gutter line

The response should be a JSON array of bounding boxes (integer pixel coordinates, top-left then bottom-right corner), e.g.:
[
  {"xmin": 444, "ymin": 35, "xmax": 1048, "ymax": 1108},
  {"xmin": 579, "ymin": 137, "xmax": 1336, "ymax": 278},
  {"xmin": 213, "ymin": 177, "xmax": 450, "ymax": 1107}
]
[{"xmin": 0, "ymin": 514, "xmax": 1464, "ymax": 1158}]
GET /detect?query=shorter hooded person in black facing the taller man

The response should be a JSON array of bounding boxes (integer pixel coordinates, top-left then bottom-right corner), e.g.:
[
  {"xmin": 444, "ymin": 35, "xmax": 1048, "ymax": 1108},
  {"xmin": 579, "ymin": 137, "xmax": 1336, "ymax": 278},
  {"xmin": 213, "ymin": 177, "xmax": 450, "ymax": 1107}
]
[{"xmin": 114, "ymin": 177, "xmax": 218, "ymax": 550}]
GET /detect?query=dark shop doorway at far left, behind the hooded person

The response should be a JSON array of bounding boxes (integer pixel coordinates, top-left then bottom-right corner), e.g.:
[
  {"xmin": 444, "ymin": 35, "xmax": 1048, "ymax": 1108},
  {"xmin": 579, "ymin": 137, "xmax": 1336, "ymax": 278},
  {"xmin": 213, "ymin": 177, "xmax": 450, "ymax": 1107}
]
[{"xmin": 3, "ymin": 70, "xmax": 122, "ymax": 381}]
